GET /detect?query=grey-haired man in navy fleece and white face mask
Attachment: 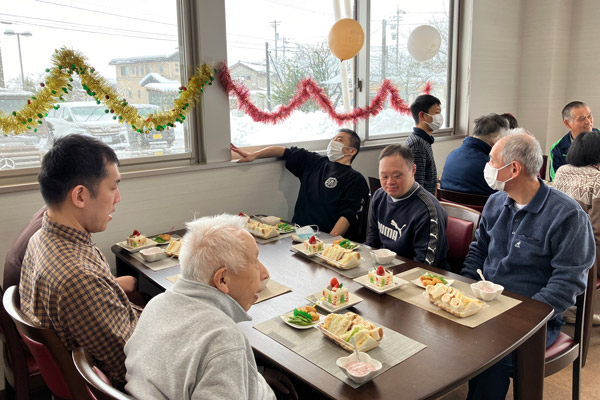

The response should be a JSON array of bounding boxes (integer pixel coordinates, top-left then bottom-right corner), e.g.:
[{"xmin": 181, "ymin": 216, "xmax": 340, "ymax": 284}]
[{"xmin": 461, "ymin": 133, "xmax": 596, "ymax": 399}]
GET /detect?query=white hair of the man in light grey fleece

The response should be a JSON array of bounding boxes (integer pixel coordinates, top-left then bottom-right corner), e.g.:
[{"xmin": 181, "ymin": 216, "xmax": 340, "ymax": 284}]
[{"xmin": 179, "ymin": 214, "xmax": 248, "ymax": 285}]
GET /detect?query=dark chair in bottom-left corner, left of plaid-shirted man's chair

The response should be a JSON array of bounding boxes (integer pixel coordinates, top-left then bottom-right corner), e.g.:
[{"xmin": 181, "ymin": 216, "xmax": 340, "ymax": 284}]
[{"xmin": 0, "ymin": 288, "xmax": 48, "ymax": 400}]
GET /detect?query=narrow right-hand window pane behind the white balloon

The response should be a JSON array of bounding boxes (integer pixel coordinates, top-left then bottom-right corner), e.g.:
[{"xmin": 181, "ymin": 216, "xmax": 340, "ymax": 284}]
[{"xmin": 366, "ymin": 0, "xmax": 451, "ymax": 138}]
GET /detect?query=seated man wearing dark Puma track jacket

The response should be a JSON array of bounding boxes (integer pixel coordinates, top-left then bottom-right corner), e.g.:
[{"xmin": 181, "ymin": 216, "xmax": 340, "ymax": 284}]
[{"xmin": 365, "ymin": 145, "xmax": 448, "ymax": 268}]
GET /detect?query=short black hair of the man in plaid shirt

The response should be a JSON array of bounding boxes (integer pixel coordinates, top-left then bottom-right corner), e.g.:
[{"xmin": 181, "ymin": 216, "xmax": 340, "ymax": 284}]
[{"xmin": 38, "ymin": 134, "xmax": 119, "ymax": 207}]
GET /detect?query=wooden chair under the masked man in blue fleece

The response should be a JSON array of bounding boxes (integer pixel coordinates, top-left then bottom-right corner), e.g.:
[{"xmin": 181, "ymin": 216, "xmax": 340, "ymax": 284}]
[{"xmin": 544, "ymin": 265, "xmax": 596, "ymax": 400}]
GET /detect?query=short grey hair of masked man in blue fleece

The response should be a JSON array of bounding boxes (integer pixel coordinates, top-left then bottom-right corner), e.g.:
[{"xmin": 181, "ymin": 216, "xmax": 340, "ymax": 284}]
[{"xmin": 502, "ymin": 132, "xmax": 543, "ymax": 177}]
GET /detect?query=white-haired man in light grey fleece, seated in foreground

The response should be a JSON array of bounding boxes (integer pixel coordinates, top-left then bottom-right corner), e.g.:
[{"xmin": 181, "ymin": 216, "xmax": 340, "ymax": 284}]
[{"xmin": 125, "ymin": 214, "xmax": 297, "ymax": 400}]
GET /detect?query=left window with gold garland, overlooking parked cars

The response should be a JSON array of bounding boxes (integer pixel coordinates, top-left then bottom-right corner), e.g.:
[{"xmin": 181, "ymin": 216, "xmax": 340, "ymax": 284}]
[{"xmin": 0, "ymin": 0, "xmax": 191, "ymax": 173}]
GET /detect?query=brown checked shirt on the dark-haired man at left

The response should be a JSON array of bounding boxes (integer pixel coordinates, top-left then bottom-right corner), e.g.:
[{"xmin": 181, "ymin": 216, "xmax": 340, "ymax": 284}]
[{"xmin": 19, "ymin": 213, "xmax": 141, "ymax": 383}]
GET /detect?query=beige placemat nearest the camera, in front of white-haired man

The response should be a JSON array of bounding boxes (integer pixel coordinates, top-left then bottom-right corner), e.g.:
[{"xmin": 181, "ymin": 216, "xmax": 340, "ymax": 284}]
[{"xmin": 254, "ymin": 316, "xmax": 427, "ymax": 388}]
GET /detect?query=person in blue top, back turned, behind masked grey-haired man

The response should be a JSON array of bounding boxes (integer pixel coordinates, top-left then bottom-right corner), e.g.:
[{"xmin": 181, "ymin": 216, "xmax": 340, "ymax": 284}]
[{"xmin": 440, "ymin": 114, "xmax": 508, "ymax": 196}]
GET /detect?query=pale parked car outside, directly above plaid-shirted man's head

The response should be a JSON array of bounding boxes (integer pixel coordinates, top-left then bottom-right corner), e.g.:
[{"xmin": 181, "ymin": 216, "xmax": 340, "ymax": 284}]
[{"xmin": 46, "ymin": 101, "xmax": 128, "ymax": 145}]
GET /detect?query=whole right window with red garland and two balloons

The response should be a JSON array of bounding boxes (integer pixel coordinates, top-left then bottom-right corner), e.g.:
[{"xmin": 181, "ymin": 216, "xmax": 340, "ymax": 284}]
[{"xmin": 225, "ymin": 0, "xmax": 453, "ymax": 146}]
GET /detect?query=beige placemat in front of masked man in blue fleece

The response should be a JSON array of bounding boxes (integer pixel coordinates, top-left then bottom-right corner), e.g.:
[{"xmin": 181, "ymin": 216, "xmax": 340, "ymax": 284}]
[{"xmin": 389, "ymin": 268, "xmax": 521, "ymax": 328}]
